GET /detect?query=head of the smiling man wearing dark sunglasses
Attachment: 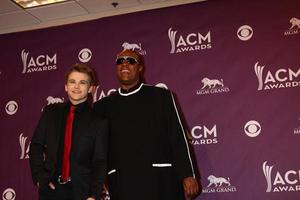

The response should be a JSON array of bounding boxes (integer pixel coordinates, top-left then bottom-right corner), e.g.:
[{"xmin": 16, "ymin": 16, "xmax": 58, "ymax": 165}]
[{"xmin": 117, "ymin": 50, "xmax": 143, "ymax": 89}]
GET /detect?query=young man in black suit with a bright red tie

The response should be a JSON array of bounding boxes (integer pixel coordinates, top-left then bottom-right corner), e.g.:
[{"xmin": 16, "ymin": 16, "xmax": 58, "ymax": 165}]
[{"xmin": 29, "ymin": 64, "xmax": 108, "ymax": 200}]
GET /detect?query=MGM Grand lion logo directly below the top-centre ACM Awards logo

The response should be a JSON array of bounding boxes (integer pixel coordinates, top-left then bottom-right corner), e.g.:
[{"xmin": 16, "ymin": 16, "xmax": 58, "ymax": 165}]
[{"xmin": 196, "ymin": 77, "xmax": 229, "ymax": 95}]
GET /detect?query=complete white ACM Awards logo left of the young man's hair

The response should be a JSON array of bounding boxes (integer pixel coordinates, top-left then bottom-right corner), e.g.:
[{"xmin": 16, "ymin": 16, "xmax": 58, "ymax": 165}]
[{"xmin": 21, "ymin": 49, "xmax": 57, "ymax": 74}]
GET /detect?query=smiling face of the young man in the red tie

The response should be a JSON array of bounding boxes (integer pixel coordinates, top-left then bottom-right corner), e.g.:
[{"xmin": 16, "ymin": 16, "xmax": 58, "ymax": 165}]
[{"xmin": 65, "ymin": 71, "xmax": 92, "ymax": 105}]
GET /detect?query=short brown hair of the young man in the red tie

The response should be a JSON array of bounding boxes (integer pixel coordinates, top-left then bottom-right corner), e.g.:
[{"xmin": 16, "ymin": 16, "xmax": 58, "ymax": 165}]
[{"xmin": 65, "ymin": 63, "xmax": 98, "ymax": 86}]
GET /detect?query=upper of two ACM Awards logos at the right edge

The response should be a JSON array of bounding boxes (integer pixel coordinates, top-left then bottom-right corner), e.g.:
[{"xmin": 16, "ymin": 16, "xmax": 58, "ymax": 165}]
[{"xmin": 254, "ymin": 62, "xmax": 300, "ymax": 90}]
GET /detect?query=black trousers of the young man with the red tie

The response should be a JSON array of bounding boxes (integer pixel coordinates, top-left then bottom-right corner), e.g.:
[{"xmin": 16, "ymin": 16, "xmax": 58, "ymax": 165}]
[{"xmin": 39, "ymin": 182, "xmax": 74, "ymax": 200}]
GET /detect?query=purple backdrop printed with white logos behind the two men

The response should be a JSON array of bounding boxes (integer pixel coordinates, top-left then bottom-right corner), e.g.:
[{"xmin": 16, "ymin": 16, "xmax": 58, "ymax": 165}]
[{"xmin": 0, "ymin": 0, "xmax": 300, "ymax": 200}]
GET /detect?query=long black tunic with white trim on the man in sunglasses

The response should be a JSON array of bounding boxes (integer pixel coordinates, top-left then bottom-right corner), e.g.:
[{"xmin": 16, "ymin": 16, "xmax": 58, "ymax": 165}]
[{"xmin": 94, "ymin": 84, "xmax": 195, "ymax": 200}]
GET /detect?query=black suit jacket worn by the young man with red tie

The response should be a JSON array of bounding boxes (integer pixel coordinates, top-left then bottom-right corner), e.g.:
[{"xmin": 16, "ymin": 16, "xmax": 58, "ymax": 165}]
[{"xmin": 29, "ymin": 103, "xmax": 108, "ymax": 200}]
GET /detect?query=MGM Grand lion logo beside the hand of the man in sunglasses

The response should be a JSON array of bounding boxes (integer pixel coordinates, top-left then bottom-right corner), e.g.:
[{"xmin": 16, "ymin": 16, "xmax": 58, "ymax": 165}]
[{"xmin": 202, "ymin": 175, "xmax": 237, "ymax": 193}]
